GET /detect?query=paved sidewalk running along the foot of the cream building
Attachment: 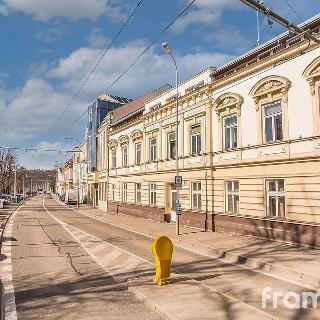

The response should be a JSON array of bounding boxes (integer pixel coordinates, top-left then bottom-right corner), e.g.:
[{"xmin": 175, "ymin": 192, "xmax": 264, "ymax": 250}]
[{"xmin": 70, "ymin": 205, "xmax": 320, "ymax": 290}]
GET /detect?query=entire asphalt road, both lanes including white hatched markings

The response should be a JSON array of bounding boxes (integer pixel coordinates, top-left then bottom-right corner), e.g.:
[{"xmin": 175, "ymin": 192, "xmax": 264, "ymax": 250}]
[{"xmin": 4, "ymin": 197, "xmax": 320, "ymax": 319}]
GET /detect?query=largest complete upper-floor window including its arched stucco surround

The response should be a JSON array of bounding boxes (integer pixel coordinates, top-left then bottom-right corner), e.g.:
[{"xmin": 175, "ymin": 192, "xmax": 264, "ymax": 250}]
[{"xmin": 249, "ymin": 75, "xmax": 291, "ymax": 144}]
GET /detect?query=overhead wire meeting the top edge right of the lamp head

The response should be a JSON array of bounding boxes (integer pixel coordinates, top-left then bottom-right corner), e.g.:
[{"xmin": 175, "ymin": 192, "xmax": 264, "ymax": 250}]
[{"xmin": 63, "ymin": 0, "xmax": 196, "ymax": 135}]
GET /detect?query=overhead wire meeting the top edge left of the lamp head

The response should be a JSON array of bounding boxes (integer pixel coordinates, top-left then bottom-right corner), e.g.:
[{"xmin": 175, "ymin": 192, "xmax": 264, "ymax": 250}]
[{"xmin": 47, "ymin": 0, "xmax": 143, "ymax": 139}]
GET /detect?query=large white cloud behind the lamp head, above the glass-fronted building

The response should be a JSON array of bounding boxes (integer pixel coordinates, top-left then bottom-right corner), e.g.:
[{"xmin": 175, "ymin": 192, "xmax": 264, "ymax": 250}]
[{"xmin": 47, "ymin": 41, "xmax": 233, "ymax": 98}]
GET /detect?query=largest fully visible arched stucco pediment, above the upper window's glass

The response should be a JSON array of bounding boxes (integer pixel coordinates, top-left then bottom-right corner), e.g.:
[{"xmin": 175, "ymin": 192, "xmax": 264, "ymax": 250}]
[{"xmin": 249, "ymin": 75, "xmax": 291, "ymax": 111}]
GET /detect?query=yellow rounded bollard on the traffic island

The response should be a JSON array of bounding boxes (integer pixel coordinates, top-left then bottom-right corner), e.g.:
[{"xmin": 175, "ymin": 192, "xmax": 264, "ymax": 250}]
[{"xmin": 152, "ymin": 236, "xmax": 173, "ymax": 286}]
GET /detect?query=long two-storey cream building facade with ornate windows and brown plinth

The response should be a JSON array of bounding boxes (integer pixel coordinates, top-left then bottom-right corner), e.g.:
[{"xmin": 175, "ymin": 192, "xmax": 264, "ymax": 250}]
[{"xmin": 92, "ymin": 17, "xmax": 320, "ymax": 243}]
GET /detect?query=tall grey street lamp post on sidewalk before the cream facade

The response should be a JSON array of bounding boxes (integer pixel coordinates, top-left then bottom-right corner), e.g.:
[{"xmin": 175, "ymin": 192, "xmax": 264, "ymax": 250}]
[{"xmin": 161, "ymin": 42, "xmax": 181, "ymax": 235}]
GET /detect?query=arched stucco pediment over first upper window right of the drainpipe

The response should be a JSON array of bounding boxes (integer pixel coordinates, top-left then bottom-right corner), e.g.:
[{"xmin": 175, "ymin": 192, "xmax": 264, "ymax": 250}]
[{"xmin": 213, "ymin": 92, "xmax": 243, "ymax": 121}]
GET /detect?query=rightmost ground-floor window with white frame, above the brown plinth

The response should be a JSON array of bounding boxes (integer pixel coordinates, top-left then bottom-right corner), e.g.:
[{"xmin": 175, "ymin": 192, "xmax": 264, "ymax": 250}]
[{"xmin": 266, "ymin": 179, "xmax": 285, "ymax": 218}]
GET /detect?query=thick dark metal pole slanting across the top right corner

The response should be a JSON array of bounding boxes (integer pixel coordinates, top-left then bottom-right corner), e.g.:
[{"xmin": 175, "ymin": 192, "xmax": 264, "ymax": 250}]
[{"xmin": 240, "ymin": 0, "xmax": 320, "ymax": 43}]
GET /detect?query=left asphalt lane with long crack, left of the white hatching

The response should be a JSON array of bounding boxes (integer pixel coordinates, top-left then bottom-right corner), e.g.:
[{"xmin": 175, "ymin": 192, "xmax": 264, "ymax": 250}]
[{"xmin": 8, "ymin": 198, "xmax": 161, "ymax": 320}]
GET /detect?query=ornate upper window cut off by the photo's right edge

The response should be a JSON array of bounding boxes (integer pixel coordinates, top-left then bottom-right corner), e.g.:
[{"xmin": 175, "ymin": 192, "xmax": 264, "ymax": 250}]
[{"xmin": 303, "ymin": 57, "xmax": 320, "ymax": 135}]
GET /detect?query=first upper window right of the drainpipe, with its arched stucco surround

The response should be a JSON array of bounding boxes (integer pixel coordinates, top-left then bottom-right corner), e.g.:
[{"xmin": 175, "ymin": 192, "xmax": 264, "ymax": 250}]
[{"xmin": 213, "ymin": 92, "xmax": 243, "ymax": 150}]
